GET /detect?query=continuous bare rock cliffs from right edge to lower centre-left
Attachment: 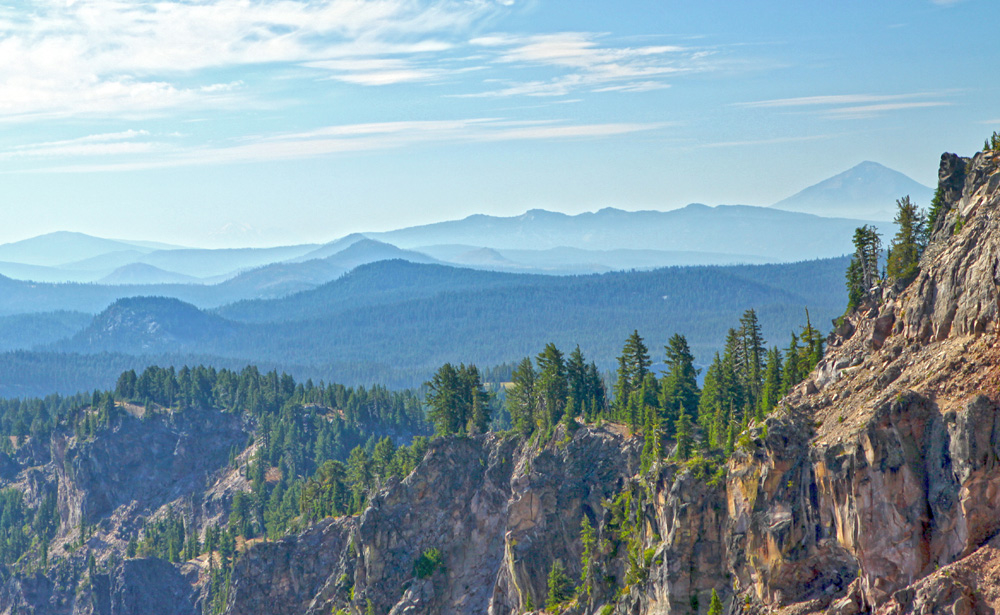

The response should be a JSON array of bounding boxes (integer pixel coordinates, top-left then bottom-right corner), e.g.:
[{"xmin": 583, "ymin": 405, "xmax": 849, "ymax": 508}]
[{"xmin": 213, "ymin": 153, "xmax": 1000, "ymax": 615}]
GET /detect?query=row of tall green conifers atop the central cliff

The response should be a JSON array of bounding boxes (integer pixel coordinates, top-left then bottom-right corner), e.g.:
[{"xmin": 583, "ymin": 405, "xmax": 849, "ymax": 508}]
[{"xmin": 426, "ymin": 309, "xmax": 824, "ymax": 465}]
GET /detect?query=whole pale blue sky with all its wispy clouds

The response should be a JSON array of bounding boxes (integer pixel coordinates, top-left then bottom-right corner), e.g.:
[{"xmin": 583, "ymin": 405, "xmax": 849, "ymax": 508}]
[{"xmin": 0, "ymin": 0, "xmax": 1000, "ymax": 247}]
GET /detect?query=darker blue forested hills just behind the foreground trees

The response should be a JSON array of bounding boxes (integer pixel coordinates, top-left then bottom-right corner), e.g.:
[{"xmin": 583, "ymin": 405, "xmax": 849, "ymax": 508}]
[{"xmin": 0, "ymin": 258, "xmax": 847, "ymax": 397}]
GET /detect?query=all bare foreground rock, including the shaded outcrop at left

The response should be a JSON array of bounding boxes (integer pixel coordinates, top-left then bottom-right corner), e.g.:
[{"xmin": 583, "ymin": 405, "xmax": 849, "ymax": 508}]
[{"xmin": 0, "ymin": 146, "xmax": 1000, "ymax": 615}]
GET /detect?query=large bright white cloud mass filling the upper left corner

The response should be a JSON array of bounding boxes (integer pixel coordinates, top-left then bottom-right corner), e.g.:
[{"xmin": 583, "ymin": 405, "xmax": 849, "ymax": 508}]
[{"xmin": 0, "ymin": 0, "xmax": 505, "ymax": 118}]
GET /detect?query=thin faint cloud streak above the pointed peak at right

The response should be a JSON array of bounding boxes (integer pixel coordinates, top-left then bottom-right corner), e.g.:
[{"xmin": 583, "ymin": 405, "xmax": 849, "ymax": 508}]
[{"xmin": 733, "ymin": 92, "xmax": 951, "ymax": 119}]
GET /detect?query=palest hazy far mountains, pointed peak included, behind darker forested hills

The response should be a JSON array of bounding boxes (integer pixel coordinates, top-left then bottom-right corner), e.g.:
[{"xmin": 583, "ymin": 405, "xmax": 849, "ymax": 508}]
[{"xmin": 0, "ymin": 162, "xmax": 931, "ymax": 288}]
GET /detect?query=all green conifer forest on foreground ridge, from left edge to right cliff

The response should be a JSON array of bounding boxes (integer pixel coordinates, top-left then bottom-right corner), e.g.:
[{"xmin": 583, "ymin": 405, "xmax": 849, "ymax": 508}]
[{"xmin": 0, "ymin": 310, "xmax": 822, "ymax": 604}]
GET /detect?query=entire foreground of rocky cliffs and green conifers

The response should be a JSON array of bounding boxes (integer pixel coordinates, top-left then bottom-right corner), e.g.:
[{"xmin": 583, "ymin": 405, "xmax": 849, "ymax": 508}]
[{"xmin": 0, "ymin": 137, "xmax": 1000, "ymax": 615}]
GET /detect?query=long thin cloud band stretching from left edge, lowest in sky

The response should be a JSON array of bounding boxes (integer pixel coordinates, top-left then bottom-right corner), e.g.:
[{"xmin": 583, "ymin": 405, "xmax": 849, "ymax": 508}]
[{"xmin": 0, "ymin": 118, "xmax": 667, "ymax": 172}]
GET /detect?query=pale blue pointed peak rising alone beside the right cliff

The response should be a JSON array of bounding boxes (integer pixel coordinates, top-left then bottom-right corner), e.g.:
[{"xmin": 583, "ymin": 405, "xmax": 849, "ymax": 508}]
[{"xmin": 772, "ymin": 161, "xmax": 934, "ymax": 222}]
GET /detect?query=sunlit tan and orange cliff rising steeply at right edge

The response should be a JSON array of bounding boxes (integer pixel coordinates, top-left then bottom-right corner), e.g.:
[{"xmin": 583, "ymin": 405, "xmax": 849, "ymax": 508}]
[{"xmin": 727, "ymin": 146, "xmax": 1000, "ymax": 613}]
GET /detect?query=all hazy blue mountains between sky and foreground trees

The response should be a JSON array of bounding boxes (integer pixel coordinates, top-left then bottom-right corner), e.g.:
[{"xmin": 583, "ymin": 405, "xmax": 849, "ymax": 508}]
[{"xmin": 0, "ymin": 163, "xmax": 928, "ymax": 395}]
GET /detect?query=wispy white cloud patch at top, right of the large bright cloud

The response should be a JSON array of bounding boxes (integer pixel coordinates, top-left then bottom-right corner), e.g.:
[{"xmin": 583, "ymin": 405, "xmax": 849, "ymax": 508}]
[{"xmin": 462, "ymin": 32, "xmax": 712, "ymax": 97}]
